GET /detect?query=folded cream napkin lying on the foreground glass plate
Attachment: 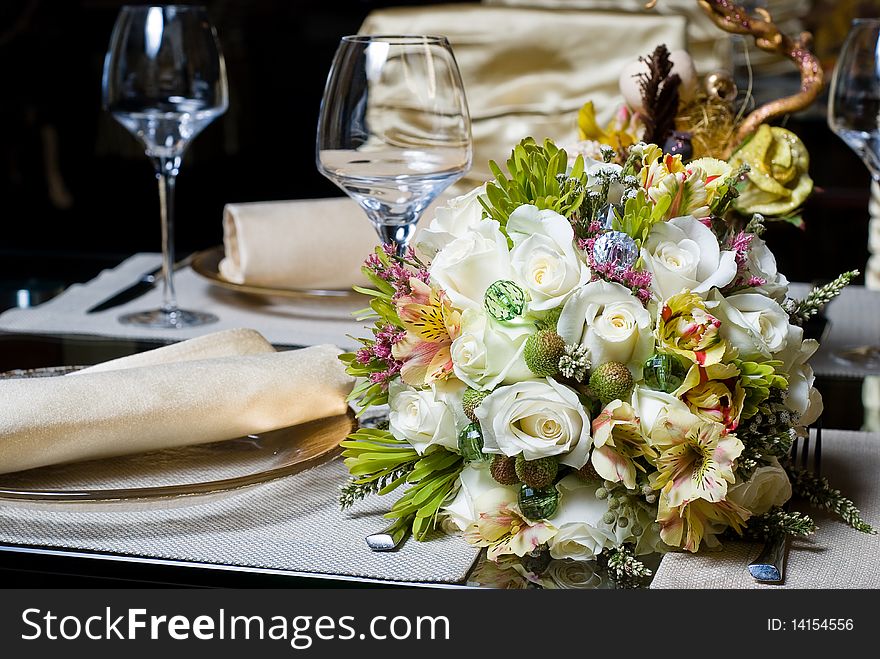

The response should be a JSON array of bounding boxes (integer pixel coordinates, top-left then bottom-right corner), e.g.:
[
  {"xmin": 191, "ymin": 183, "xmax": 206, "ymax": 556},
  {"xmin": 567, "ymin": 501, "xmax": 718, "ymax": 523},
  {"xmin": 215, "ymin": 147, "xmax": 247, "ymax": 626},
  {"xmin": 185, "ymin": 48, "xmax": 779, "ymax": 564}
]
[{"xmin": 0, "ymin": 332, "xmax": 353, "ymax": 473}]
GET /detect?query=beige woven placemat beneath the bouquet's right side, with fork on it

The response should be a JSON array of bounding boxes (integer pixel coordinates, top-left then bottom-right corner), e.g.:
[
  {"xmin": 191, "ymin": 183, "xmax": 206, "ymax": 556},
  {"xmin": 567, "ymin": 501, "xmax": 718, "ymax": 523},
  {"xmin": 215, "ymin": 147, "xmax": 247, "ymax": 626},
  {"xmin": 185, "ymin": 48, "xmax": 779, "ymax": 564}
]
[{"xmin": 651, "ymin": 430, "xmax": 880, "ymax": 589}]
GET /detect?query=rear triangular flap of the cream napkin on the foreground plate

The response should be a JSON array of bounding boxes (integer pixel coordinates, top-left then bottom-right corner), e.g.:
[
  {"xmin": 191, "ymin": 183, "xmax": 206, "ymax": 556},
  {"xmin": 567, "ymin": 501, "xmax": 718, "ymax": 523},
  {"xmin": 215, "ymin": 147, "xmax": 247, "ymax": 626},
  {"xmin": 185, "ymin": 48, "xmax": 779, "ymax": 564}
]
[{"xmin": 77, "ymin": 328, "xmax": 275, "ymax": 376}]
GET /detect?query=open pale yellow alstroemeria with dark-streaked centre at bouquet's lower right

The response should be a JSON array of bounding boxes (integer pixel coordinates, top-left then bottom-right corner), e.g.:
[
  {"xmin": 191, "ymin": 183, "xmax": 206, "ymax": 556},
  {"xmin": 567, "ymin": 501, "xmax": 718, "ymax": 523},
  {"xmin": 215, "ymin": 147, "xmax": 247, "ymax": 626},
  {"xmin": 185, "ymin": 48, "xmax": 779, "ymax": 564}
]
[{"xmin": 650, "ymin": 408, "xmax": 743, "ymax": 508}]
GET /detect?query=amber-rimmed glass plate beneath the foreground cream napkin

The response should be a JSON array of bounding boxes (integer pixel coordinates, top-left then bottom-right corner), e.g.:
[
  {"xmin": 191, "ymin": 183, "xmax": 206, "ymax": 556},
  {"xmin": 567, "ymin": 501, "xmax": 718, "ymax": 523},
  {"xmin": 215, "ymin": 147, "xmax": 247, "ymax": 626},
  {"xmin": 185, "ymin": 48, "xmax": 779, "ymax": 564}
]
[{"xmin": 0, "ymin": 366, "xmax": 356, "ymax": 509}]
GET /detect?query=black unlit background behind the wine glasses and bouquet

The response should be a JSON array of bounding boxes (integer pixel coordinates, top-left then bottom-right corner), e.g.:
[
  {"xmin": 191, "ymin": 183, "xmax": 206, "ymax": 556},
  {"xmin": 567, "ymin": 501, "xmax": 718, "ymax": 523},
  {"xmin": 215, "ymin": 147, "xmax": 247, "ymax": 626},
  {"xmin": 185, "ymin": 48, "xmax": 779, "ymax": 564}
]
[{"xmin": 0, "ymin": 0, "xmax": 880, "ymax": 300}]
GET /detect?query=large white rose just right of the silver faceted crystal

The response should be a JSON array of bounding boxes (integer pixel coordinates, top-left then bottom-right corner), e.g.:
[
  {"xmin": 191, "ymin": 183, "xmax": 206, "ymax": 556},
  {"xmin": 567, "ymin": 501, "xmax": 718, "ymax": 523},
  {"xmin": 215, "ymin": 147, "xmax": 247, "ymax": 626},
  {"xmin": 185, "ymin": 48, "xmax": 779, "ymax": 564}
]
[{"xmin": 641, "ymin": 216, "xmax": 736, "ymax": 300}]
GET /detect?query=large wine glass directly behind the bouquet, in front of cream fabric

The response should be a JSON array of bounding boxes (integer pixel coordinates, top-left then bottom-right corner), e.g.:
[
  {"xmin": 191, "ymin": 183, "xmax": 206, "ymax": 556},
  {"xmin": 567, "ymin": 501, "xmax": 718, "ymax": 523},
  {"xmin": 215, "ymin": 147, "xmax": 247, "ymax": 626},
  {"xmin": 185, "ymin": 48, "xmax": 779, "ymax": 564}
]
[{"xmin": 316, "ymin": 36, "xmax": 473, "ymax": 256}]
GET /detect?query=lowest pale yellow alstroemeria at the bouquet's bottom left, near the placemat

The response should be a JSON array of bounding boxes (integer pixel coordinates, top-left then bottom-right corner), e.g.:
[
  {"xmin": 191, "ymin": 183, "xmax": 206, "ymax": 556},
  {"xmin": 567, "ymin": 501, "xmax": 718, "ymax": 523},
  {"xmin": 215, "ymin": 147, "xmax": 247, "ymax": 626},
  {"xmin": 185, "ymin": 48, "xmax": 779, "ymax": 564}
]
[{"xmin": 464, "ymin": 487, "xmax": 556, "ymax": 561}]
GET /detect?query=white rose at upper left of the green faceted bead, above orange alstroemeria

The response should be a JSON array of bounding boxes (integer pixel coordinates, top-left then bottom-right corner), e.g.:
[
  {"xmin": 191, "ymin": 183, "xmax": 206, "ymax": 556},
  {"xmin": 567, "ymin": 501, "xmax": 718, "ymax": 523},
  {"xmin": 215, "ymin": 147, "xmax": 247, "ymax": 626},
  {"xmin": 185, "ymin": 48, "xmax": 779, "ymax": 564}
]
[{"xmin": 430, "ymin": 220, "xmax": 514, "ymax": 309}]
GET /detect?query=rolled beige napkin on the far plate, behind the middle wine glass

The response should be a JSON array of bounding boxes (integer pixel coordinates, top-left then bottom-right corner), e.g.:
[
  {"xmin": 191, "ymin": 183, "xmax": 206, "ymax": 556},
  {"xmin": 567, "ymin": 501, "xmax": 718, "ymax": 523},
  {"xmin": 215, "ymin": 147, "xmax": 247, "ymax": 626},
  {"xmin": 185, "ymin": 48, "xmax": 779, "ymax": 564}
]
[{"xmin": 219, "ymin": 197, "xmax": 379, "ymax": 290}]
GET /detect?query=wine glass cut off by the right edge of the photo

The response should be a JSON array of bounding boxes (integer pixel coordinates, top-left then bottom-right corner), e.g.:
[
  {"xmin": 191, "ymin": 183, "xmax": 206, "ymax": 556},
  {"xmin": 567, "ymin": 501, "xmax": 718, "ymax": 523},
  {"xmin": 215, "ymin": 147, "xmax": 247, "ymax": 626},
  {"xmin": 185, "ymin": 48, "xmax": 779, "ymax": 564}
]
[{"xmin": 828, "ymin": 18, "xmax": 880, "ymax": 370}]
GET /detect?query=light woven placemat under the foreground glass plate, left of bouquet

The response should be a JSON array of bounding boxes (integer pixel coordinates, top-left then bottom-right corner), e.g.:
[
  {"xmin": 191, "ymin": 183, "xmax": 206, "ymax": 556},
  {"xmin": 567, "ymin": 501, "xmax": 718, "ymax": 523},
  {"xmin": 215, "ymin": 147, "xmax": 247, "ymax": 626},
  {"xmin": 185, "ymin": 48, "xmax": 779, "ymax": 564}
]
[{"xmin": 0, "ymin": 459, "xmax": 478, "ymax": 583}]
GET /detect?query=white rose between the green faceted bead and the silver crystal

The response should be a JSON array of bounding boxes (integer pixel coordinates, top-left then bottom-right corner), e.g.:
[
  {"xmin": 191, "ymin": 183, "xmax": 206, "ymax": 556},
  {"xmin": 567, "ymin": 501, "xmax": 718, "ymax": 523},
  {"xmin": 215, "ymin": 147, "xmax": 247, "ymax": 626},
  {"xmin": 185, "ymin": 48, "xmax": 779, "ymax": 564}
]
[{"xmin": 507, "ymin": 204, "xmax": 590, "ymax": 311}]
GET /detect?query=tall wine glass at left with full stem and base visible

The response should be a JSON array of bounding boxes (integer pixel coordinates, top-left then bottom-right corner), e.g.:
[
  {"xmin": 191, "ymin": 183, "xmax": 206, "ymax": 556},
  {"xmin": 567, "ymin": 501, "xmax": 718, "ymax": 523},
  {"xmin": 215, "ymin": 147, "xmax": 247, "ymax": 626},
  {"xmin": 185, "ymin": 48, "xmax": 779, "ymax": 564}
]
[{"xmin": 102, "ymin": 5, "xmax": 229, "ymax": 328}]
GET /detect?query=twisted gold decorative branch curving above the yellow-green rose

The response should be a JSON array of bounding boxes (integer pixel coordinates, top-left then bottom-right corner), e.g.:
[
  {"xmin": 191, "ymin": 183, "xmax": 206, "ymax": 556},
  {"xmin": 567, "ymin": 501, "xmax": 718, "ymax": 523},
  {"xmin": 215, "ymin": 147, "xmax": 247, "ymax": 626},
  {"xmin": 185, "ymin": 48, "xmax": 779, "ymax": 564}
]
[{"xmin": 697, "ymin": 0, "xmax": 825, "ymax": 155}]
